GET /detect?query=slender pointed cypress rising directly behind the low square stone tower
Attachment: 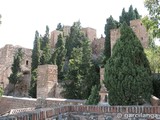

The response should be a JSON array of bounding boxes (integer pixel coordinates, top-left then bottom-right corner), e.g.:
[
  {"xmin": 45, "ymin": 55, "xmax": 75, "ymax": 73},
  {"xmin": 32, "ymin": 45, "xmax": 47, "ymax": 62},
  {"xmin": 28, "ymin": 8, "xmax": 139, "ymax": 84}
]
[{"xmin": 40, "ymin": 26, "xmax": 51, "ymax": 65}]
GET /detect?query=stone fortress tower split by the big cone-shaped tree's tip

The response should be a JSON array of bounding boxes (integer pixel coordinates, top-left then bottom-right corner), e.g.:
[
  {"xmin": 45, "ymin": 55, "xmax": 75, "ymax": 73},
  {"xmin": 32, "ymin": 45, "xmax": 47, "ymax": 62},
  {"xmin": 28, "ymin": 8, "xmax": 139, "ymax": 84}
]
[{"xmin": 110, "ymin": 19, "xmax": 148, "ymax": 52}]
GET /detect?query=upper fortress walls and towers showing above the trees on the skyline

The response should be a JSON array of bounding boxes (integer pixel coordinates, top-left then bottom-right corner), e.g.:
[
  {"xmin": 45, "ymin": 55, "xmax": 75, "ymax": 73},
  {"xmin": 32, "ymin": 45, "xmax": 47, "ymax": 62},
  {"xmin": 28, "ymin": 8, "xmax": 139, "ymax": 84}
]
[{"xmin": 51, "ymin": 19, "xmax": 148, "ymax": 58}]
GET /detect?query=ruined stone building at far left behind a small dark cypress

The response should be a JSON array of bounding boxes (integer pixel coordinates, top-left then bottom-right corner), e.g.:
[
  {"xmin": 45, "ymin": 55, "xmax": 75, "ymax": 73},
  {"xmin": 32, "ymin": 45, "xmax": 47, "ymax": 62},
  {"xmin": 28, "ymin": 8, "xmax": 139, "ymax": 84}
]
[{"xmin": 0, "ymin": 45, "xmax": 32, "ymax": 96}]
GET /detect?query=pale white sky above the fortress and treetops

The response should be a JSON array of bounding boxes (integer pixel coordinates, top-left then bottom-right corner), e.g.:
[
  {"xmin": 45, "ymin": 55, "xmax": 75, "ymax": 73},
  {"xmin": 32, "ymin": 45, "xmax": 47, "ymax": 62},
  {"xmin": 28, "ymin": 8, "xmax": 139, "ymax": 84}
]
[{"xmin": 0, "ymin": 0, "xmax": 148, "ymax": 48}]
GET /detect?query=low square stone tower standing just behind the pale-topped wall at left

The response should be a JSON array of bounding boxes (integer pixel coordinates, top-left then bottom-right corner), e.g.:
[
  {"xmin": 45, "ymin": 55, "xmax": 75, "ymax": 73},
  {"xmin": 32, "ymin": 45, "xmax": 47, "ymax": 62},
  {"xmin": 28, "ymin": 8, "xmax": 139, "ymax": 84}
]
[{"xmin": 37, "ymin": 65, "xmax": 58, "ymax": 98}]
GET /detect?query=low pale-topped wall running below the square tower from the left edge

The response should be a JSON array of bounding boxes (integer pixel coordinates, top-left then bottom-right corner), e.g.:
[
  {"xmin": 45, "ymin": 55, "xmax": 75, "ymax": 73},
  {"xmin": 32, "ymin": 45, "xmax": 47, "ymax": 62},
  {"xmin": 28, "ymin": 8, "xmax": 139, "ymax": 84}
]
[{"xmin": 0, "ymin": 96, "xmax": 85, "ymax": 115}]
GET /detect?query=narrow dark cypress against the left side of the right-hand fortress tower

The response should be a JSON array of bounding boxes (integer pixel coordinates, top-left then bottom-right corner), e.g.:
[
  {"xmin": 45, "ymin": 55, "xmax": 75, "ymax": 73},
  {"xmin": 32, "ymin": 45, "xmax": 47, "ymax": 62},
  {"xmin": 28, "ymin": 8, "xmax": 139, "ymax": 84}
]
[{"xmin": 104, "ymin": 16, "xmax": 118, "ymax": 61}]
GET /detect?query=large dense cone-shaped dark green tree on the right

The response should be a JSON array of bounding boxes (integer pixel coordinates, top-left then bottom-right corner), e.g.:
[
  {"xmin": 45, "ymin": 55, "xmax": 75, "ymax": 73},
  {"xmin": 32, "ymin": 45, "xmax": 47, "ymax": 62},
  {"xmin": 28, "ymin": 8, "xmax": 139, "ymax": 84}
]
[{"xmin": 104, "ymin": 23, "xmax": 153, "ymax": 105}]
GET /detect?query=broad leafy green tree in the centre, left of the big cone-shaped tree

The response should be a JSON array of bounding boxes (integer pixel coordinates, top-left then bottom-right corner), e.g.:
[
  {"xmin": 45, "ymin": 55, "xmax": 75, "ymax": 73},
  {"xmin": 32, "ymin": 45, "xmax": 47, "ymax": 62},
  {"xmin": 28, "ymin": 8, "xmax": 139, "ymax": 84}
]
[{"xmin": 63, "ymin": 38, "xmax": 99, "ymax": 99}]
